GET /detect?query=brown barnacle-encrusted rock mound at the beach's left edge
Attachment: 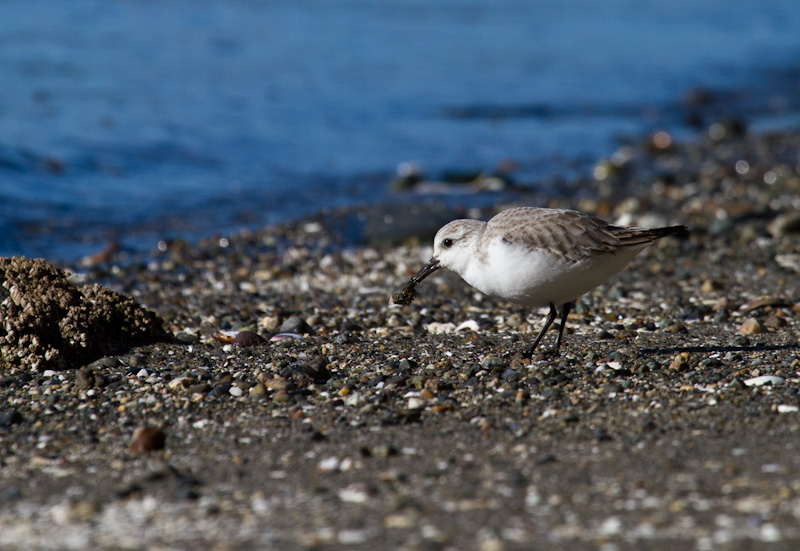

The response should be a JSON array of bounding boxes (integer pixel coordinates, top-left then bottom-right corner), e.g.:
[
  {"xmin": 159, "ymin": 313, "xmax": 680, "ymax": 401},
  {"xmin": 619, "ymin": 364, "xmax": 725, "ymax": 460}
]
[{"xmin": 0, "ymin": 257, "xmax": 167, "ymax": 370}]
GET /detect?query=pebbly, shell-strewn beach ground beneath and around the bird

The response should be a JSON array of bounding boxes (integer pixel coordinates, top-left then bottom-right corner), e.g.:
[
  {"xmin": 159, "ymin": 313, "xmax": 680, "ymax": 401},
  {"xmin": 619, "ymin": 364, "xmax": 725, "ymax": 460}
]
[{"xmin": 0, "ymin": 123, "xmax": 800, "ymax": 550}]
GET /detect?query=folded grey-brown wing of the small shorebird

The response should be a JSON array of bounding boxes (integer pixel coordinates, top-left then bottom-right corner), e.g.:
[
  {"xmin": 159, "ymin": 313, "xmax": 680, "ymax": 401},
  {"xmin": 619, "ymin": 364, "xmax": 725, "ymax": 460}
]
[{"xmin": 488, "ymin": 207, "xmax": 685, "ymax": 260}]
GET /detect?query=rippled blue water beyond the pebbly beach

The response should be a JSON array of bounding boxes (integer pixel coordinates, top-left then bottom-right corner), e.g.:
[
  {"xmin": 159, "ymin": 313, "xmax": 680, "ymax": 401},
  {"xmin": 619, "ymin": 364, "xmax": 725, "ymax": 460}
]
[{"xmin": 0, "ymin": 0, "xmax": 800, "ymax": 259}]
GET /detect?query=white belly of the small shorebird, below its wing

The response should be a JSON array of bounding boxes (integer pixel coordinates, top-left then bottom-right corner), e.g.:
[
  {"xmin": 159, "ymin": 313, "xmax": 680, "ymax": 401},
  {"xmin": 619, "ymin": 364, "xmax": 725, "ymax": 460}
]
[{"xmin": 462, "ymin": 242, "xmax": 644, "ymax": 307}]
